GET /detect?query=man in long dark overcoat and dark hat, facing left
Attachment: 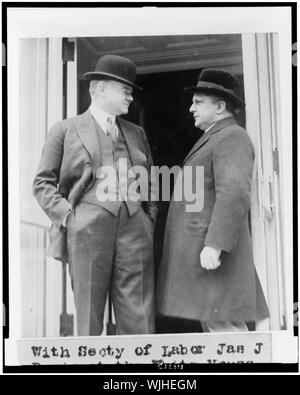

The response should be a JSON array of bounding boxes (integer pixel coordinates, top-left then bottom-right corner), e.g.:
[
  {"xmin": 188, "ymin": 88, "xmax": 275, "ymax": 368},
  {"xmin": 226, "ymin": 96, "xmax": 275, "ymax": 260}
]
[{"xmin": 157, "ymin": 69, "xmax": 269, "ymax": 332}]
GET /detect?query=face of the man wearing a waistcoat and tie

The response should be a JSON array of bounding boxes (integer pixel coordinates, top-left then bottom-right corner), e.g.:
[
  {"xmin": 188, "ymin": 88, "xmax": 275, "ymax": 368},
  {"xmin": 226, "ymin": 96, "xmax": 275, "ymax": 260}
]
[{"xmin": 98, "ymin": 81, "xmax": 133, "ymax": 115}]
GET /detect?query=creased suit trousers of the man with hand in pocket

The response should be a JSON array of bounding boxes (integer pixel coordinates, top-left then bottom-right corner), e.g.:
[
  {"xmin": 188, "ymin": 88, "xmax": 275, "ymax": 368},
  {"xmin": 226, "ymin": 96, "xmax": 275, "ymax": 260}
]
[{"xmin": 67, "ymin": 202, "xmax": 155, "ymax": 336}]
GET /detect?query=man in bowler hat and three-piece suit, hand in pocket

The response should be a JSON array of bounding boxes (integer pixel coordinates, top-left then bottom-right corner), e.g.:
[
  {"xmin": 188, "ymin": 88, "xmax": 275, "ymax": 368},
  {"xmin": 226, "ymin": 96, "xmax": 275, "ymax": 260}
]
[{"xmin": 33, "ymin": 55, "xmax": 156, "ymax": 336}]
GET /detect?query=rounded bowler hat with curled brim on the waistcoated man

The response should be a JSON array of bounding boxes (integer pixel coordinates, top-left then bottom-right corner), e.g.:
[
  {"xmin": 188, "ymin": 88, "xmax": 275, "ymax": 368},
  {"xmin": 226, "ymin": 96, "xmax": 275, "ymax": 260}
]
[{"xmin": 83, "ymin": 55, "xmax": 142, "ymax": 90}]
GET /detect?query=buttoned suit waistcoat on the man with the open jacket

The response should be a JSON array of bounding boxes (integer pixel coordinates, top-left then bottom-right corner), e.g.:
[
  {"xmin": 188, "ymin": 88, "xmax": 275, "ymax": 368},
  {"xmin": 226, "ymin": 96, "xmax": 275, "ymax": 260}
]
[{"xmin": 82, "ymin": 120, "xmax": 141, "ymax": 215}]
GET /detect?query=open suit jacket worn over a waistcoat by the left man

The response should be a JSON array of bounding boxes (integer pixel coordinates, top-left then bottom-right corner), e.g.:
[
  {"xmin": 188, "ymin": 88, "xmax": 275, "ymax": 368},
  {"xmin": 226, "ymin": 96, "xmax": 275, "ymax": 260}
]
[{"xmin": 33, "ymin": 110, "xmax": 156, "ymax": 261}]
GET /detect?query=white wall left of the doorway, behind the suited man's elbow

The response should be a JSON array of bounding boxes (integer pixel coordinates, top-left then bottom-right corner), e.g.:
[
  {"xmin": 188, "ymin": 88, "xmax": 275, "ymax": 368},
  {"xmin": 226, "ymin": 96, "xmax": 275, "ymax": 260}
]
[{"xmin": 19, "ymin": 39, "xmax": 74, "ymax": 337}]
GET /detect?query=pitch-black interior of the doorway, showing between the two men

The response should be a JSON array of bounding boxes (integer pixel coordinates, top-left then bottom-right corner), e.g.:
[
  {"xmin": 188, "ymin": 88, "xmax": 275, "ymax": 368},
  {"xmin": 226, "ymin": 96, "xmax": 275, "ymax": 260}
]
[{"xmin": 78, "ymin": 70, "xmax": 244, "ymax": 333}]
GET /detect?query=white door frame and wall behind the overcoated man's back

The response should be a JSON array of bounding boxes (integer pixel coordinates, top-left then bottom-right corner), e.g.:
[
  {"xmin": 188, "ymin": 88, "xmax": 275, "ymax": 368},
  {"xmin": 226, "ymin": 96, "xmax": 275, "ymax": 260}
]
[{"xmin": 243, "ymin": 33, "xmax": 293, "ymax": 330}]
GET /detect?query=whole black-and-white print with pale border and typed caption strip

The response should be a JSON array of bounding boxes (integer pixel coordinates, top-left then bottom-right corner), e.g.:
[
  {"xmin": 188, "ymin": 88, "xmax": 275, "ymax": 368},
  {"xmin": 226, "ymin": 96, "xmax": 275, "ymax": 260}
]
[{"xmin": 3, "ymin": 3, "xmax": 298, "ymax": 373}]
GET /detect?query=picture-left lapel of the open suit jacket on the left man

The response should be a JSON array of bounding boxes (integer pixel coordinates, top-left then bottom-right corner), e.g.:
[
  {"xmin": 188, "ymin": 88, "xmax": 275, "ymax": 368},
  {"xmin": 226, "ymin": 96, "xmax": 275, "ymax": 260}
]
[{"xmin": 76, "ymin": 110, "xmax": 101, "ymax": 171}]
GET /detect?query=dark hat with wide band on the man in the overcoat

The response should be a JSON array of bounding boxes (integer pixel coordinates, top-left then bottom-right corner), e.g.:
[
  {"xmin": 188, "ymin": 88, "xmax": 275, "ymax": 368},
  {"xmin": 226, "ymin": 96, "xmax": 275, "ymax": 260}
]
[{"xmin": 184, "ymin": 69, "xmax": 245, "ymax": 107}]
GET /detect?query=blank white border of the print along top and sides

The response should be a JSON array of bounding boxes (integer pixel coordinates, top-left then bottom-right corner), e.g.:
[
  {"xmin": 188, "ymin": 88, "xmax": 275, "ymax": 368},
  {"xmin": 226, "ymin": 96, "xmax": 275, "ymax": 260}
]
[{"xmin": 3, "ymin": 6, "xmax": 294, "ymax": 368}]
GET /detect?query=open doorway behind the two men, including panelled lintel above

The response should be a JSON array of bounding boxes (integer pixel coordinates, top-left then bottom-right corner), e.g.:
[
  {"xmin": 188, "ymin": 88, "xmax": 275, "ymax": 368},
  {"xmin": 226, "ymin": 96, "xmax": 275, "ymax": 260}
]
[{"xmin": 77, "ymin": 35, "xmax": 245, "ymax": 333}]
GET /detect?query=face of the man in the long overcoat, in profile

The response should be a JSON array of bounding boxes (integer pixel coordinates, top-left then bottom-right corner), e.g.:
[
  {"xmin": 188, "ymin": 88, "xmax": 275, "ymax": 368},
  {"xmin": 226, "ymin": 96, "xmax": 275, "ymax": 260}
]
[{"xmin": 190, "ymin": 93, "xmax": 218, "ymax": 130}]
